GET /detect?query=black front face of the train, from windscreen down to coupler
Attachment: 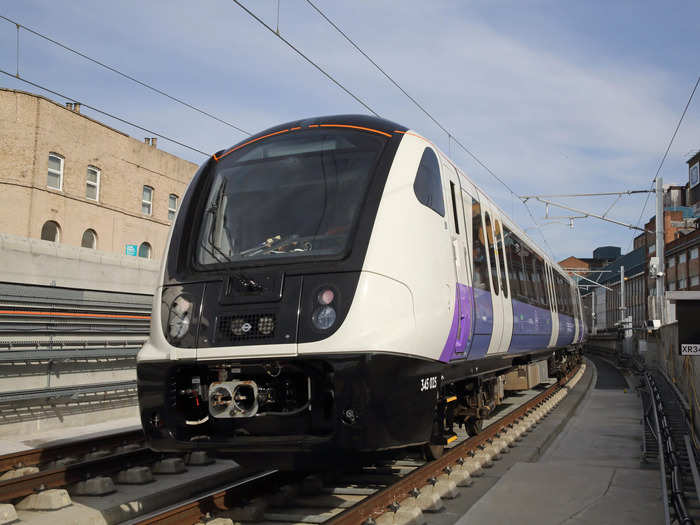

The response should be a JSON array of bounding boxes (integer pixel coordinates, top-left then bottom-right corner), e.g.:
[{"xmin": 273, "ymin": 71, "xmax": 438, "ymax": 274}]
[{"xmin": 137, "ymin": 116, "xmax": 430, "ymax": 462}]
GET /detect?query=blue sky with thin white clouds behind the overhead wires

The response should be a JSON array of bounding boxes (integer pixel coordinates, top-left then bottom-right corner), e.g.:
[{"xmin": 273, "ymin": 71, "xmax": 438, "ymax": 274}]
[{"xmin": 0, "ymin": 0, "xmax": 700, "ymax": 260}]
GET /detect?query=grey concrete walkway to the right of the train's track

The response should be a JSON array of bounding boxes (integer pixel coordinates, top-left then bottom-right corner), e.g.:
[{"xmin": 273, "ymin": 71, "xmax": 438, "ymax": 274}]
[{"xmin": 457, "ymin": 358, "xmax": 663, "ymax": 525}]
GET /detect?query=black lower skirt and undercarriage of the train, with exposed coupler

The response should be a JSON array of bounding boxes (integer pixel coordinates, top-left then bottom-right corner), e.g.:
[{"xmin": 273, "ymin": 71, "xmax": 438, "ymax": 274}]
[{"xmin": 137, "ymin": 350, "xmax": 578, "ymax": 468}]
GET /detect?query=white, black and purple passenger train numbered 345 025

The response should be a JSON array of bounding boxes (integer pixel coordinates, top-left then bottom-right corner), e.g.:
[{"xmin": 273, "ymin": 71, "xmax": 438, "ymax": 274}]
[{"xmin": 137, "ymin": 115, "xmax": 587, "ymax": 462}]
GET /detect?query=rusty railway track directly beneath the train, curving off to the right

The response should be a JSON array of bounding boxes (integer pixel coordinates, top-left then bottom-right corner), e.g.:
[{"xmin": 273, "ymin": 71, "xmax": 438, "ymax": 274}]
[{"xmin": 129, "ymin": 365, "xmax": 585, "ymax": 525}]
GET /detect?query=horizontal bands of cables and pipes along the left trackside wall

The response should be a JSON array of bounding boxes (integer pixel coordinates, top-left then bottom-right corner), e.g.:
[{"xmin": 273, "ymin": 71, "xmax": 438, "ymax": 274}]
[{"xmin": 0, "ymin": 283, "xmax": 152, "ymax": 416}]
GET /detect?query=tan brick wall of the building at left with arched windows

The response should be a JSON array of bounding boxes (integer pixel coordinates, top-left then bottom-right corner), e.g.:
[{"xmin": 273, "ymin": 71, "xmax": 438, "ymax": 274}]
[{"xmin": 0, "ymin": 89, "xmax": 197, "ymax": 259}]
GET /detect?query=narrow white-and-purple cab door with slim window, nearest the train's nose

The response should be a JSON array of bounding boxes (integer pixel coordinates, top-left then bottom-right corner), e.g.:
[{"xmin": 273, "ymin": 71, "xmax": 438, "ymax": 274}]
[{"xmin": 442, "ymin": 161, "xmax": 471, "ymax": 358}]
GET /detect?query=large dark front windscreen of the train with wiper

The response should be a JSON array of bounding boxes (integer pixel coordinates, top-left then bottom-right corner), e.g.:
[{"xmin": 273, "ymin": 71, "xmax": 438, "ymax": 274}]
[{"xmin": 196, "ymin": 128, "xmax": 386, "ymax": 265}]
